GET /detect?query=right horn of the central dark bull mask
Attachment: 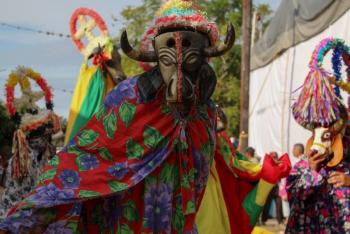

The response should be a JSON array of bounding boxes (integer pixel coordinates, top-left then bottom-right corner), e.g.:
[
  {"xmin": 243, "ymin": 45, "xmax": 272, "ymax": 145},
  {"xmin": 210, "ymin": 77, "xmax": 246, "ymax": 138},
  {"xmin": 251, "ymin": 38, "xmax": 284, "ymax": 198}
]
[{"xmin": 204, "ymin": 24, "xmax": 236, "ymax": 57}]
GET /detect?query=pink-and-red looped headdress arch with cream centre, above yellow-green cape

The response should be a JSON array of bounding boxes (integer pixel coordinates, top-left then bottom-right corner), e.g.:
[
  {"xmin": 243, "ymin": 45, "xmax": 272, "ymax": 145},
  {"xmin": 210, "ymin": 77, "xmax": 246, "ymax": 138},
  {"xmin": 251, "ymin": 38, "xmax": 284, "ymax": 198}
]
[{"xmin": 70, "ymin": 8, "xmax": 111, "ymax": 58}]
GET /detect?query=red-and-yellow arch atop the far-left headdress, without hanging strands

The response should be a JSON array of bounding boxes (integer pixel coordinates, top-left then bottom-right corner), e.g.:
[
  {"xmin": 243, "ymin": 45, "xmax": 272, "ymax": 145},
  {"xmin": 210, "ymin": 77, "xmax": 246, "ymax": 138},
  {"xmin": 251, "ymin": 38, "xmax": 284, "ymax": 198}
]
[{"xmin": 5, "ymin": 66, "xmax": 53, "ymax": 117}]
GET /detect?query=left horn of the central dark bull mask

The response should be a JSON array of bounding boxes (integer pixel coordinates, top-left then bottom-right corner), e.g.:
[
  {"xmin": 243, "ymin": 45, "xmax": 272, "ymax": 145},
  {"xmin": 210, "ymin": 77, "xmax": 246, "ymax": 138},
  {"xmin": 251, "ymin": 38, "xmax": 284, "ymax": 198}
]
[{"xmin": 120, "ymin": 30, "xmax": 157, "ymax": 63}]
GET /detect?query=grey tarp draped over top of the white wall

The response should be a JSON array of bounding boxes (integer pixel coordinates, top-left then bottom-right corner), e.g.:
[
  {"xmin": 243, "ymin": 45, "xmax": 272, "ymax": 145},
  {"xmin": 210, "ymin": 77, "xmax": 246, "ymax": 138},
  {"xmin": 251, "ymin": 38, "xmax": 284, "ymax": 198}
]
[{"xmin": 251, "ymin": 0, "xmax": 350, "ymax": 70}]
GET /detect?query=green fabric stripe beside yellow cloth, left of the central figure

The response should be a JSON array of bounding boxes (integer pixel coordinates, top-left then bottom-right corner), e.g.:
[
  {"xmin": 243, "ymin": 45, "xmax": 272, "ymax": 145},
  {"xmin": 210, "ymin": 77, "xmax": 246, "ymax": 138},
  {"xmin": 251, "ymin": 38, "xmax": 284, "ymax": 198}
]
[{"xmin": 69, "ymin": 68, "xmax": 105, "ymax": 139}]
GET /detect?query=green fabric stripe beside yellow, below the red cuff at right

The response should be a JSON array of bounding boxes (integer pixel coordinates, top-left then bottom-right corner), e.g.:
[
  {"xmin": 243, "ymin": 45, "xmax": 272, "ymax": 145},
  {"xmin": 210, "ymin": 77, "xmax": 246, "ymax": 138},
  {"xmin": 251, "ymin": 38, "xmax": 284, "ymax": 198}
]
[{"xmin": 243, "ymin": 186, "xmax": 263, "ymax": 227}]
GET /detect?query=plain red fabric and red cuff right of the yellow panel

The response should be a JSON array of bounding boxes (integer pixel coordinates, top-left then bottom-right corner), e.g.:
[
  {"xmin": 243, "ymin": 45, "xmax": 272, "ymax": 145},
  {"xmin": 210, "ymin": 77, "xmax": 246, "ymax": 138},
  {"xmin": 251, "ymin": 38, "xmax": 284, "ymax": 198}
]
[{"xmin": 214, "ymin": 132, "xmax": 291, "ymax": 234}]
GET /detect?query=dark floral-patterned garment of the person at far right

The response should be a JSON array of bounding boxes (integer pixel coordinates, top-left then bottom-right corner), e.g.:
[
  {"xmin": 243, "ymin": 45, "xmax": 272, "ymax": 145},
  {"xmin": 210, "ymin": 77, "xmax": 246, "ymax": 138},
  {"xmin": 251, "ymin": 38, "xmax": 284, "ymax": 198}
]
[{"xmin": 286, "ymin": 159, "xmax": 350, "ymax": 234}]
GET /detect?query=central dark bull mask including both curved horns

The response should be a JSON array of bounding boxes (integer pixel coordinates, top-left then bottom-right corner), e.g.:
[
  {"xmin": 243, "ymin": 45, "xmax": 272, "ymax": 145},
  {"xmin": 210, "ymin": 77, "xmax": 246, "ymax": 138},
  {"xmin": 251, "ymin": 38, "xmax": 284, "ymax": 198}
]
[{"xmin": 121, "ymin": 25, "xmax": 235, "ymax": 106}]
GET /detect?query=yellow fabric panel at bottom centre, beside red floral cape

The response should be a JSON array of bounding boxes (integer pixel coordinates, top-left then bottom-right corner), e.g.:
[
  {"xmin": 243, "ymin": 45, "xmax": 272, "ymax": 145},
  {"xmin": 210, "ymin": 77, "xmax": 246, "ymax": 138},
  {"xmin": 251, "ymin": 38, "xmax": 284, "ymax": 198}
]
[{"xmin": 196, "ymin": 161, "xmax": 231, "ymax": 234}]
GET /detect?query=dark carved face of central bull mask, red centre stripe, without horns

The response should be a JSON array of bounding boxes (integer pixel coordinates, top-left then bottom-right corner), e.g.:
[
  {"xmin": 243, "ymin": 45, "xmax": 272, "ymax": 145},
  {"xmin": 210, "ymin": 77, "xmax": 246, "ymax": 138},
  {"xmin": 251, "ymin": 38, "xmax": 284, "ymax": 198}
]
[{"xmin": 154, "ymin": 31, "xmax": 211, "ymax": 103}]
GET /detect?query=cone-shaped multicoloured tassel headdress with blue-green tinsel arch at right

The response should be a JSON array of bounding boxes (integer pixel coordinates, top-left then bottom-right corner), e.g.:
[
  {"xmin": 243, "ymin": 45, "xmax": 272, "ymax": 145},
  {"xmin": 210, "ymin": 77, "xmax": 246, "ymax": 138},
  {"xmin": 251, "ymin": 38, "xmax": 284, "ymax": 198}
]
[{"xmin": 292, "ymin": 38, "xmax": 350, "ymax": 130}]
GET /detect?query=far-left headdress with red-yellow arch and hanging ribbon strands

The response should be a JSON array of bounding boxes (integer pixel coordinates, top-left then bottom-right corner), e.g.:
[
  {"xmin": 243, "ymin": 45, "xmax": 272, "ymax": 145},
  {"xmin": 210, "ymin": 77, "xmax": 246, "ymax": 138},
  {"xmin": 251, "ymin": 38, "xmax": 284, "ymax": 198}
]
[{"xmin": 5, "ymin": 66, "xmax": 60, "ymax": 179}]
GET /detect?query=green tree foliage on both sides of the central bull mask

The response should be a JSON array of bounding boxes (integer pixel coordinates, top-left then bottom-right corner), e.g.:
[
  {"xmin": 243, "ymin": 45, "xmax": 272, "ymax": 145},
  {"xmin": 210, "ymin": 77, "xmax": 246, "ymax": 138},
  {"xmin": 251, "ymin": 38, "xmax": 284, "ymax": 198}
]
[{"xmin": 122, "ymin": 0, "xmax": 270, "ymax": 136}]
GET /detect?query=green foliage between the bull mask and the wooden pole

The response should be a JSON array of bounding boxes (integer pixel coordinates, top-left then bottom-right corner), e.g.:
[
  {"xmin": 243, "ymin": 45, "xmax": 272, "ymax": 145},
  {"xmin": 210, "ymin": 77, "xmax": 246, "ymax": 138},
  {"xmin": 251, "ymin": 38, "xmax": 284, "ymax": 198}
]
[{"xmin": 198, "ymin": 0, "xmax": 242, "ymax": 136}]
